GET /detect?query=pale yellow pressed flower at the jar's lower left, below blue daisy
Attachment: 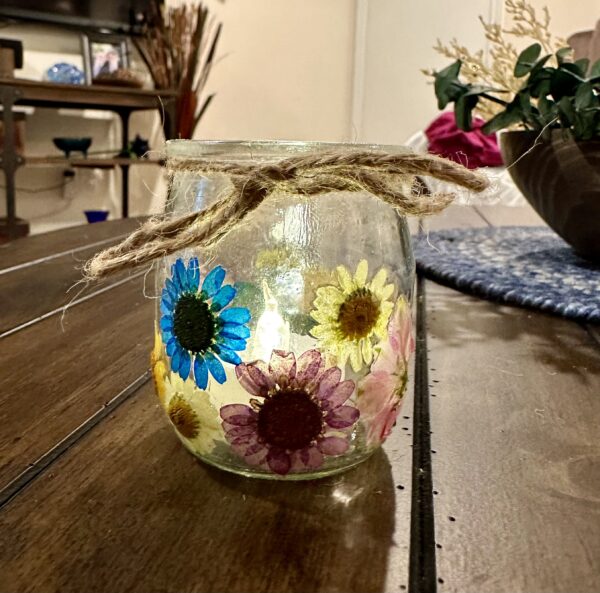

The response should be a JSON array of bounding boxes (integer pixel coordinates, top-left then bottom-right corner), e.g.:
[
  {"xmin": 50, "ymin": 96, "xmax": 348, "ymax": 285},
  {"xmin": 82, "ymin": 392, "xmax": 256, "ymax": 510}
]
[{"xmin": 164, "ymin": 373, "xmax": 223, "ymax": 454}]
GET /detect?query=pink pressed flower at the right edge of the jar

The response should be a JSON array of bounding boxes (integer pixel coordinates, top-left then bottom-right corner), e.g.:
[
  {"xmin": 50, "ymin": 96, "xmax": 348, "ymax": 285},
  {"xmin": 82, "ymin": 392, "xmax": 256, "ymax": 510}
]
[{"xmin": 357, "ymin": 299, "xmax": 415, "ymax": 445}]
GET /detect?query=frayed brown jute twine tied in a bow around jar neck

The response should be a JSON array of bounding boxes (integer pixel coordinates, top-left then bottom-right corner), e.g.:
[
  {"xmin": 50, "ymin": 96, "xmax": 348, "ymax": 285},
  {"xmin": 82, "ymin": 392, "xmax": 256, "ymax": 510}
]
[{"xmin": 84, "ymin": 150, "xmax": 489, "ymax": 280}]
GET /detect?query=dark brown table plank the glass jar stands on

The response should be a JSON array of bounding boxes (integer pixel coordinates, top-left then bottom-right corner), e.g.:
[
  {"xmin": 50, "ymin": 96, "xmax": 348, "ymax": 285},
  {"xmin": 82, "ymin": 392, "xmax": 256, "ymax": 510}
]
[{"xmin": 0, "ymin": 386, "xmax": 418, "ymax": 593}]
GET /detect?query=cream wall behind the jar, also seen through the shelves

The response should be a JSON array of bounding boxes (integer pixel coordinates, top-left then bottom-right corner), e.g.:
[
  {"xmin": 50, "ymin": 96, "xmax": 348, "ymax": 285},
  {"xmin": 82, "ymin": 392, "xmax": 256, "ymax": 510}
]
[{"xmin": 0, "ymin": 0, "xmax": 598, "ymax": 233}]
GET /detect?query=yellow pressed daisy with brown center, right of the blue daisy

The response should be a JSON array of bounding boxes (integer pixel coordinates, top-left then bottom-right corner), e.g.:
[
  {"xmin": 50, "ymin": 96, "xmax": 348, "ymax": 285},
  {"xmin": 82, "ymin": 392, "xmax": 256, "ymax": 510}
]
[{"xmin": 311, "ymin": 259, "xmax": 394, "ymax": 372}]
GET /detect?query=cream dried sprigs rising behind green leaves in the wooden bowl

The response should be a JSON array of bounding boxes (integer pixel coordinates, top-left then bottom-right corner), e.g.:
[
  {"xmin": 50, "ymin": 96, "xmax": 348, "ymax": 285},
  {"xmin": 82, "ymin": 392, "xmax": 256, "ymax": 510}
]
[{"xmin": 422, "ymin": 0, "xmax": 567, "ymax": 120}]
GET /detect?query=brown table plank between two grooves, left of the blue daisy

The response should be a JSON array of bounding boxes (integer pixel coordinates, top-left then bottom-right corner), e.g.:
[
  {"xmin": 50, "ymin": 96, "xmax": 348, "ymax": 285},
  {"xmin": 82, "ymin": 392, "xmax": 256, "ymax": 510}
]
[{"xmin": 0, "ymin": 278, "xmax": 154, "ymax": 487}]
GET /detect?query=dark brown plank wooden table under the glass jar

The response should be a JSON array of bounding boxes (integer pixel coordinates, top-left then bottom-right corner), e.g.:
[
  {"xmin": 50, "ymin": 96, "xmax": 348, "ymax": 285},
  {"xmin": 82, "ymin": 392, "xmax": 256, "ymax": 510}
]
[{"xmin": 0, "ymin": 207, "xmax": 600, "ymax": 593}]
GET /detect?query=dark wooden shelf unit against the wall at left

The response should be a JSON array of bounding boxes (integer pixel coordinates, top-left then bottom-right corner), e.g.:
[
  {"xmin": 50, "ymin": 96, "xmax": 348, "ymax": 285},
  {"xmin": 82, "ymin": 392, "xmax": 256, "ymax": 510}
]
[{"xmin": 0, "ymin": 78, "xmax": 177, "ymax": 239}]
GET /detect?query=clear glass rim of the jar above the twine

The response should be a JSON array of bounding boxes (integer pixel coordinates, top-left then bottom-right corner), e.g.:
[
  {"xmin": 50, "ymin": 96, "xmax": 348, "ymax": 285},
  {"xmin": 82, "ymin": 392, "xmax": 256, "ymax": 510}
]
[{"xmin": 166, "ymin": 140, "xmax": 409, "ymax": 160}]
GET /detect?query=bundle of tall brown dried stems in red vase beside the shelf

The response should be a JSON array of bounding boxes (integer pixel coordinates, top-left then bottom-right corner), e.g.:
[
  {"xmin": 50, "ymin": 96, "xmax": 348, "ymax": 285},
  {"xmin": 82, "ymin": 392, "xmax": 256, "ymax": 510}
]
[{"xmin": 134, "ymin": 0, "xmax": 221, "ymax": 138}]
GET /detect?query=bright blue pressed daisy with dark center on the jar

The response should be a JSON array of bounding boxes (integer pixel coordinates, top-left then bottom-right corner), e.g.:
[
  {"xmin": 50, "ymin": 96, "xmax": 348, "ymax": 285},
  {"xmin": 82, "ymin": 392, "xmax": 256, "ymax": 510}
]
[{"xmin": 160, "ymin": 257, "xmax": 250, "ymax": 389}]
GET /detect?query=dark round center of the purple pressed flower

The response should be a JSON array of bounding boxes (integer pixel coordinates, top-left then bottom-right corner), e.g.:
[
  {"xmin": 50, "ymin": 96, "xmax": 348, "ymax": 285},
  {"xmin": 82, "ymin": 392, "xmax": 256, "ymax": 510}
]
[{"xmin": 258, "ymin": 389, "xmax": 323, "ymax": 450}]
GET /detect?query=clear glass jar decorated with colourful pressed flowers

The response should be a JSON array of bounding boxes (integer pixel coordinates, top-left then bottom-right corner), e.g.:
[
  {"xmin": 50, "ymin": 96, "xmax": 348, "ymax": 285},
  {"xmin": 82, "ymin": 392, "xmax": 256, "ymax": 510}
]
[{"xmin": 152, "ymin": 140, "xmax": 414, "ymax": 480}]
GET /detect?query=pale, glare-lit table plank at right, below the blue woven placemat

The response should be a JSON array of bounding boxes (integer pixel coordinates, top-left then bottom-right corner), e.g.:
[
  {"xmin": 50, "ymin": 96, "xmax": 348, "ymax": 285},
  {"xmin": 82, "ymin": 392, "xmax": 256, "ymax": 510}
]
[{"xmin": 427, "ymin": 283, "xmax": 600, "ymax": 593}]
